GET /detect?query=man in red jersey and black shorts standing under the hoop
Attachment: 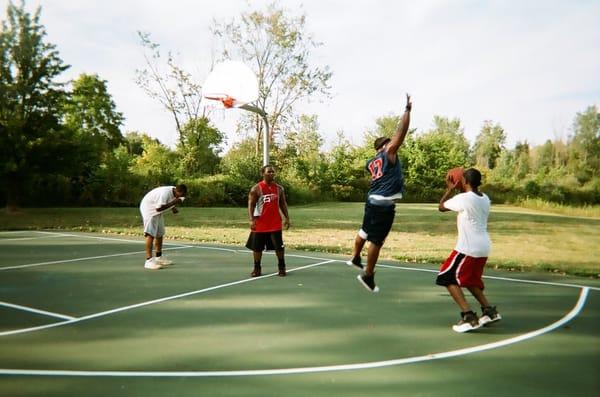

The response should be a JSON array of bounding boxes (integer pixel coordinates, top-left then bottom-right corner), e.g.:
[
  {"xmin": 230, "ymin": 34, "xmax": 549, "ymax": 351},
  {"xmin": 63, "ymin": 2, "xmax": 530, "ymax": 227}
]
[{"xmin": 246, "ymin": 164, "xmax": 290, "ymax": 277}]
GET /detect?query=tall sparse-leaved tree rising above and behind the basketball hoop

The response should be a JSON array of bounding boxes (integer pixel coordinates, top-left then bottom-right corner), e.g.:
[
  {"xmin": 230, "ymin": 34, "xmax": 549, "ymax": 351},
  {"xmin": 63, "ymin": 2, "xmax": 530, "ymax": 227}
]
[{"xmin": 212, "ymin": 3, "xmax": 332, "ymax": 153}]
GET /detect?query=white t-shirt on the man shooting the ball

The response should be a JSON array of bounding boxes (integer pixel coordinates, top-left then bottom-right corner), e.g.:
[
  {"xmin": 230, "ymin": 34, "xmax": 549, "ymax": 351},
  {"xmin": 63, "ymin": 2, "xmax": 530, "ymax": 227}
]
[{"xmin": 444, "ymin": 192, "xmax": 492, "ymax": 258}]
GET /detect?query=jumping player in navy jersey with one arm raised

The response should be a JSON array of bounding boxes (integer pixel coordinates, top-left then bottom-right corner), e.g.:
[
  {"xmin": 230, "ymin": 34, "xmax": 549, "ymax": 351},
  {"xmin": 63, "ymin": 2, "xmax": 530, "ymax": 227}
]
[{"xmin": 346, "ymin": 94, "xmax": 412, "ymax": 292}]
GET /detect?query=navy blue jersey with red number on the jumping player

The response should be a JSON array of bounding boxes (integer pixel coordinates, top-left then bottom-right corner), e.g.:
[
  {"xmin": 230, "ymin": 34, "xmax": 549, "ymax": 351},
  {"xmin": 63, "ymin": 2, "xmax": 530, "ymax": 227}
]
[{"xmin": 366, "ymin": 150, "xmax": 404, "ymax": 203}]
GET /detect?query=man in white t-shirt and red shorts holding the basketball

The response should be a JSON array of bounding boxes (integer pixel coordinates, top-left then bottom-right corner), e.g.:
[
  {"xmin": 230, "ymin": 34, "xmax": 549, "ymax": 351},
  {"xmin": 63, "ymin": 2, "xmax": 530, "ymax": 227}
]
[{"xmin": 436, "ymin": 168, "xmax": 501, "ymax": 332}]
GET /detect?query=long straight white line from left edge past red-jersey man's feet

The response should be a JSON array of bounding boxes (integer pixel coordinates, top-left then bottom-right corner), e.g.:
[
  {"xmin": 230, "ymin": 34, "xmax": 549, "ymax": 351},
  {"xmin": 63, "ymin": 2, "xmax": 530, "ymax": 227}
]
[{"xmin": 0, "ymin": 260, "xmax": 333, "ymax": 336}]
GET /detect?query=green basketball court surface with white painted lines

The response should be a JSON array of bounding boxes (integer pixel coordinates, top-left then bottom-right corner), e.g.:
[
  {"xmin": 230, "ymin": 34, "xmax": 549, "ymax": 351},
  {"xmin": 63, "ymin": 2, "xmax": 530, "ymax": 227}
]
[{"xmin": 0, "ymin": 231, "xmax": 600, "ymax": 396}]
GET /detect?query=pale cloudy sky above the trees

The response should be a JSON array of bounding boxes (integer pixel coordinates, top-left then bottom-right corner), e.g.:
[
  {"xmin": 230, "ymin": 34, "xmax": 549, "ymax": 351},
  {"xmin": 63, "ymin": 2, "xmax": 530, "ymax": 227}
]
[{"xmin": 0, "ymin": 0, "xmax": 600, "ymax": 147}]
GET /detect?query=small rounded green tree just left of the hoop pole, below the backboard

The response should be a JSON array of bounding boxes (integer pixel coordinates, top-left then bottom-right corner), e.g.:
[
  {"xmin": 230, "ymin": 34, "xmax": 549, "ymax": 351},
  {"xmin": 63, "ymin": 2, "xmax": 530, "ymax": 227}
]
[{"xmin": 177, "ymin": 117, "xmax": 224, "ymax": 177}]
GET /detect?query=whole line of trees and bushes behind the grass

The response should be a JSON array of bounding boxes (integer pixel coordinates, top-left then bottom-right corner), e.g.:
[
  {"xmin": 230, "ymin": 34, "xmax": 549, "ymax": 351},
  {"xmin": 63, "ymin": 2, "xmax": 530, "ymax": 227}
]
[{"xmin": 0, "ymin": 3, "xmax": 600, "ymax": 207}]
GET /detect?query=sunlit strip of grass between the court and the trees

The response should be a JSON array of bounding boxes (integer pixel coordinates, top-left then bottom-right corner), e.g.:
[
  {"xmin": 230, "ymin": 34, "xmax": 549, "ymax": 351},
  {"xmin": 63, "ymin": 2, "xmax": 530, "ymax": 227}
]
[{"xmin": 0, "ymin": 203, "xmax": 600, "ymax": 278}]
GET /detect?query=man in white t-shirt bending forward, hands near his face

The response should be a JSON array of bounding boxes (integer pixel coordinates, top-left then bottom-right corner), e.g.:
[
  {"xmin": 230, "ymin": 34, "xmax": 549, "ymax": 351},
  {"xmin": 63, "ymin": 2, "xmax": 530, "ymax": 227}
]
[{"xmin": 140, "ymin": 185, "xmax": 187, "ymax": 270}]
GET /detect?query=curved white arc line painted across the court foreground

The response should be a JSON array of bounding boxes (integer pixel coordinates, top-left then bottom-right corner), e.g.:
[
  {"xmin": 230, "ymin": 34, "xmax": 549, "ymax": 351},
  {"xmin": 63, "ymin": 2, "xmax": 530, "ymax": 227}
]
[{"xmin": 0, "ymin": 287, "xmax": 589, "ymax": 377}]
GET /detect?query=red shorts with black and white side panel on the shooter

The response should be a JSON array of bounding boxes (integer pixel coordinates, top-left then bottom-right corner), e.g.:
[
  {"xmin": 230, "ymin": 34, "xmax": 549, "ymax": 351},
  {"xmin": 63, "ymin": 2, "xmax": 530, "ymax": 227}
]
[{"xmin": 435, "ymin": 250, "xmax": 487, "ymax": 289}]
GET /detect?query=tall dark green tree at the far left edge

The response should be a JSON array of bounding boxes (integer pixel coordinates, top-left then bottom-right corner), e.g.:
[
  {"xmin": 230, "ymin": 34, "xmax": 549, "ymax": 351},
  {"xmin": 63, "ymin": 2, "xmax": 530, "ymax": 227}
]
[{"xmin": 0, "ymin": 2, "xmax": 74, "ymax": 208}]
